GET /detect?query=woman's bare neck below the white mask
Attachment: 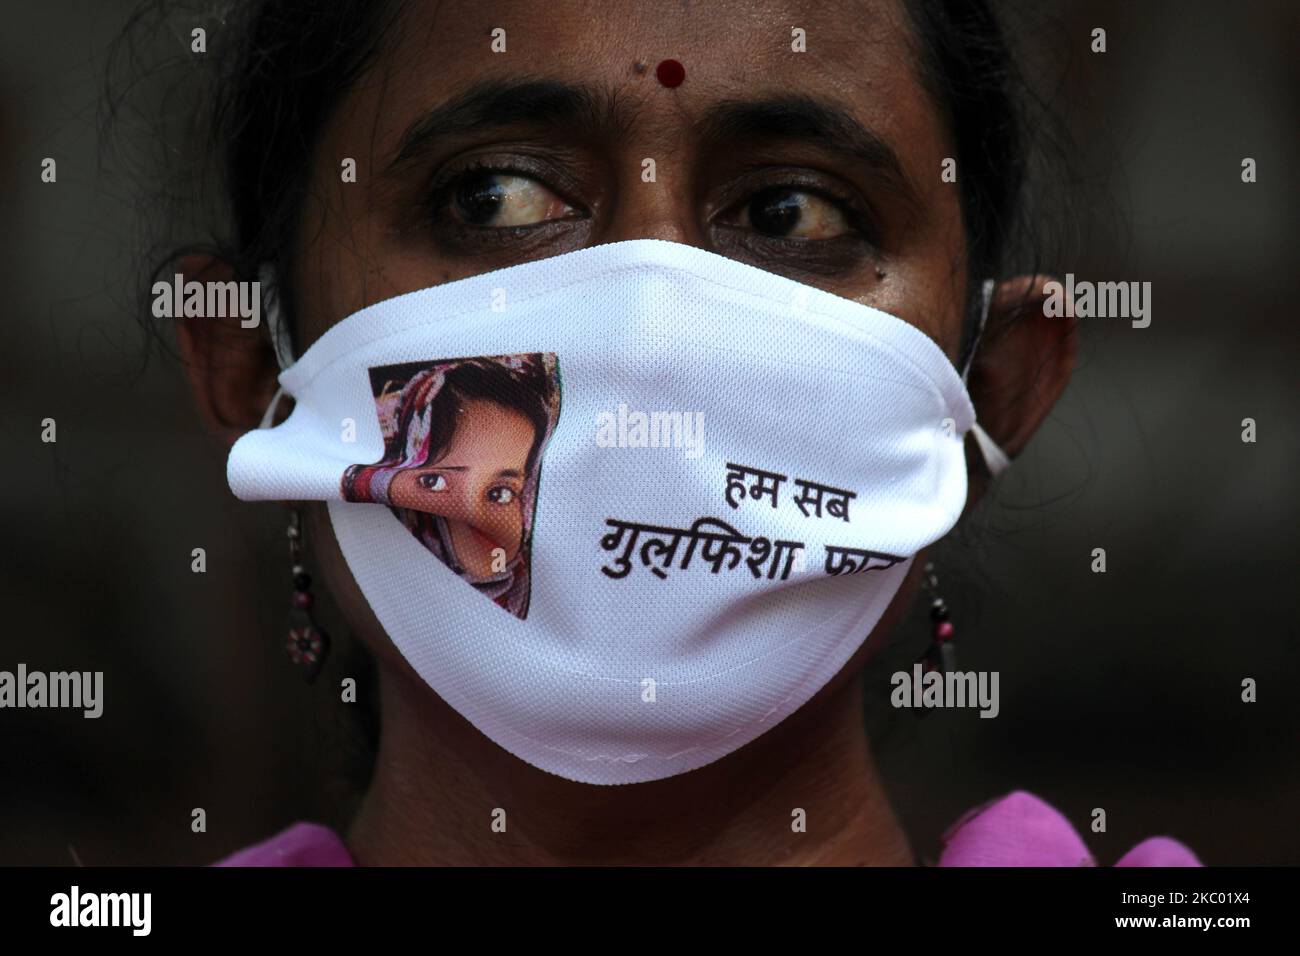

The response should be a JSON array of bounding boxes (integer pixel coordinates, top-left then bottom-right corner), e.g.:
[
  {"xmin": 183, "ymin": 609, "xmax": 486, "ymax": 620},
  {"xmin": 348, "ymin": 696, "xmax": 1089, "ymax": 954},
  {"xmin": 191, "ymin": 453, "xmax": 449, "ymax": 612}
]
[{"xmin": 347, "ymin": 667, "xmax": 913, "ymax": 866}]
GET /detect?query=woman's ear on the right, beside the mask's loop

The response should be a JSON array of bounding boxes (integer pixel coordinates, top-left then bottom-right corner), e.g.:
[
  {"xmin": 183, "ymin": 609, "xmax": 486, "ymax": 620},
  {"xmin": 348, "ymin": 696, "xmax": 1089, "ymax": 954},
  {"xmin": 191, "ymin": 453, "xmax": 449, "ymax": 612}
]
[{"xmin": 967, "ymin": 276, "xmax": 1078, "ymax": 468}]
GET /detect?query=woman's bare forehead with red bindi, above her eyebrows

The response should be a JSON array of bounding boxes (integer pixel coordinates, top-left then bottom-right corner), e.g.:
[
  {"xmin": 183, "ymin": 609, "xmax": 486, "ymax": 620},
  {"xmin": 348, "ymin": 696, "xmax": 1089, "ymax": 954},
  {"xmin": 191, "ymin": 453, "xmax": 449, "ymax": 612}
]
[{"xmin": 364, "ymin": 0, "xmax": 918, "ymax": 143}]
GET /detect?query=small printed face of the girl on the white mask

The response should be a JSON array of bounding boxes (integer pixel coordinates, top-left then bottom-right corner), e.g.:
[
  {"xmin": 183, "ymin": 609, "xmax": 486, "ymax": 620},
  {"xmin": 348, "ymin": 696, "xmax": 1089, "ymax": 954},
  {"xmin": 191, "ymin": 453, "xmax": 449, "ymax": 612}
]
[{"xmin": 389, "ymin": 399, "xmax": 536, "ymax": 578}]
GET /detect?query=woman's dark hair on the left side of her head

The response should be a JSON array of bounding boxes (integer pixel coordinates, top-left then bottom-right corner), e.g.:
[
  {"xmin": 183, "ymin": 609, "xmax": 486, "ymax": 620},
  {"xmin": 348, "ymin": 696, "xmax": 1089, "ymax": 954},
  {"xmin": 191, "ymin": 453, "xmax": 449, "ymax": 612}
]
[{"xmin": 104, "ymin": 0, "xmax": 404, "ymax": 356}]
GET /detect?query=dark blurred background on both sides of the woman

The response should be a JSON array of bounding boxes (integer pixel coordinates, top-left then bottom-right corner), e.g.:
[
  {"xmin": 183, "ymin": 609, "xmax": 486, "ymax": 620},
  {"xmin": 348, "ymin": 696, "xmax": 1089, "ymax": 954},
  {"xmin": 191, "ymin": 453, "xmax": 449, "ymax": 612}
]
[{"xmin": 0, "ymin": 0, "xmax": 1300, "ymax": 866}]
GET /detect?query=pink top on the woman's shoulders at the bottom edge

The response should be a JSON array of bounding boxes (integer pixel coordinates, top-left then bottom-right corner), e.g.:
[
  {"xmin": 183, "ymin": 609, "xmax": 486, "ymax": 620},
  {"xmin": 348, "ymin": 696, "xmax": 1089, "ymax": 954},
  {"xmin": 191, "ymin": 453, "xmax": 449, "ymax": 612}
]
[{"xmin": 215, "ymin": 791, "xmax": 1201, "ymax": 866}]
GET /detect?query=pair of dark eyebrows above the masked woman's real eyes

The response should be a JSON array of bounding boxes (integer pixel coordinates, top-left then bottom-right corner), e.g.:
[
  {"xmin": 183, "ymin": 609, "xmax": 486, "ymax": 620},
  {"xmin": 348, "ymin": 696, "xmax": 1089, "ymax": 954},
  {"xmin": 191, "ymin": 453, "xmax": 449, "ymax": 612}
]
[{"xmin": 386, "ymin": 77, "xmax": 917, "ymax": 199}]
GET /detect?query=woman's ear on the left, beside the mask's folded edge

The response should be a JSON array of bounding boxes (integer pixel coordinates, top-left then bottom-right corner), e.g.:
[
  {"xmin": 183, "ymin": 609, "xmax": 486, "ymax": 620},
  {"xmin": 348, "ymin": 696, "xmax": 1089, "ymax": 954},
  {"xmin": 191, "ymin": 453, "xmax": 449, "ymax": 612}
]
[{"xmin": 174, "ymin": 255, "xmax": 280, "ymax": 445}]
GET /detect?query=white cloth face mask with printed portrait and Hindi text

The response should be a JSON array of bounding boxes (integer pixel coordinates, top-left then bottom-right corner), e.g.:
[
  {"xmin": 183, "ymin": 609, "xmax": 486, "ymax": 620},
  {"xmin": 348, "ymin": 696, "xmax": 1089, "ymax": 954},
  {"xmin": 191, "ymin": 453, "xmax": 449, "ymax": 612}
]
[{"xmin": 228, "ymin": 239, "xmax": 1005, "ymax": 784}]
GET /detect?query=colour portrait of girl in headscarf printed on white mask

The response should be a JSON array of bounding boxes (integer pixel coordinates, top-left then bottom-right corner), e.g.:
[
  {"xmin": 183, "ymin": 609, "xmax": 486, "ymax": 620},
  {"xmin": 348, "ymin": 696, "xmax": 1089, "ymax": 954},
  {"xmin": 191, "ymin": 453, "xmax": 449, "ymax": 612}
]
[{"xmin": 342, "ymin": 354, "xmax": 560, "ymax": 618}]
